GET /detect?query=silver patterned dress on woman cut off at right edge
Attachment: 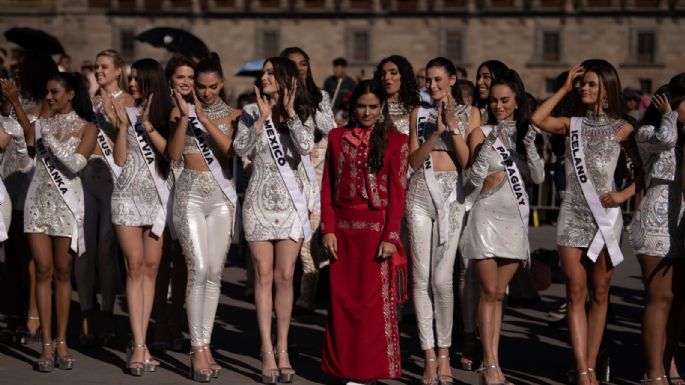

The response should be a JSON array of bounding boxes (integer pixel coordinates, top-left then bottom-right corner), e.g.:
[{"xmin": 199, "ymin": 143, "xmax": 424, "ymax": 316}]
[{"xmin": 629, "ymin": 111, "xmax": 685, "ymax": 257}]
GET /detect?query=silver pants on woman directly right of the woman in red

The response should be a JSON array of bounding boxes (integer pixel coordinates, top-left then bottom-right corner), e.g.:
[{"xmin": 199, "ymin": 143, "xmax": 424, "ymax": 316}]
[{"xmin": 405, "ymin": 171, "xmax": 464, "ymax": 350}]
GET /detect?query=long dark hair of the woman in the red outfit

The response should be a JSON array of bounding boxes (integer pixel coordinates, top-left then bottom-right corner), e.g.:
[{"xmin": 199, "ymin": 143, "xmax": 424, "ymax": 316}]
[{"xmin": 347, "ymin": 80, "xmax": 395, "ymax": 173}]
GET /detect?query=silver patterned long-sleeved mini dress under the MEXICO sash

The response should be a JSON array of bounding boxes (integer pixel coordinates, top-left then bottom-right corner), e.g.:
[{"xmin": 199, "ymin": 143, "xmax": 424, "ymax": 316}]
[{"xmin": 233, "ymin": 103, "xmax": 318, "ymax": 241}]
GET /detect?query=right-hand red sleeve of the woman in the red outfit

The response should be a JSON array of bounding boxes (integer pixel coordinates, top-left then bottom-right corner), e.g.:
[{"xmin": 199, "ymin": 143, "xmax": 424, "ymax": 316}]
[{"xmin": 382, "ymin": 133, "xmax": 409, "ymax": 247}]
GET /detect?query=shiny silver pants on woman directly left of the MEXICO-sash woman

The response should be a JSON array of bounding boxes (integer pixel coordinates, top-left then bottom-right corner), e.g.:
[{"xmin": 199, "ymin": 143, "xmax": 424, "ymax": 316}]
[{"xmin": 173, "ymin": 170, "xmax": 235, "ymax": 346}]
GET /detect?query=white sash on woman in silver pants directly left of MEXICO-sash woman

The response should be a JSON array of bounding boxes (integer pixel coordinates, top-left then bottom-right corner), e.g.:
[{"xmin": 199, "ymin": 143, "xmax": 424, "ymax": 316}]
[{"xmin": 188, "ymin": 104, "xmax": 240, "ymax": 227}]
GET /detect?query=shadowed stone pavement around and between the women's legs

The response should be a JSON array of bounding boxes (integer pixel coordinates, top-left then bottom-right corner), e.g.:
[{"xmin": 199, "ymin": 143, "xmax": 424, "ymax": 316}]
[{"xmin": 0, "ymin": 226, "xmax": 672, "ymax": 385}]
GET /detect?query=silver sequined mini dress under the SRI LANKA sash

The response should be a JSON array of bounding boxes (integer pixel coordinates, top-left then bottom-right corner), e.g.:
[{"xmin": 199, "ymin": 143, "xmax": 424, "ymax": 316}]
[{"xmin": 24, "ymin": 111, "xmax": 86, "ymax": 238}]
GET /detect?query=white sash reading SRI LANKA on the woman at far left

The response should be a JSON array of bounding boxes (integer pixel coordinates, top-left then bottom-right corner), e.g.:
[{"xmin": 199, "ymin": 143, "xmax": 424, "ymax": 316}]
[{"xmin": 35, "ymin": 119, "xmax": 86, "ymax": 256}]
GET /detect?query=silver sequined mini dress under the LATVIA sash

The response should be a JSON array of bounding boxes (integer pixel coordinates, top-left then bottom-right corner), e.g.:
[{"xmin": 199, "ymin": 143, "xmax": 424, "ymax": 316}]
[{"xmin": 112, "ymin": 106, "xmax": 166, "ymax": 226}]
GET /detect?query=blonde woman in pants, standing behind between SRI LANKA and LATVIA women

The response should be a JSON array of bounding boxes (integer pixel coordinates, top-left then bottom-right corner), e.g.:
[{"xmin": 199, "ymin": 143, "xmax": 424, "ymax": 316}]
[{"xmin": 74, "ymin": 50, "xmax": 133, "ymax": 347}]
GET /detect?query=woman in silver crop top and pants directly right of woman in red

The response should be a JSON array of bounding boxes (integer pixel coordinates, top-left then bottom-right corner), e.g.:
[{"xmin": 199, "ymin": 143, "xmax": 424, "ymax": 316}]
[{"xmin": 406, "ymin": 57, "xmax": 480, "ymax": 384}]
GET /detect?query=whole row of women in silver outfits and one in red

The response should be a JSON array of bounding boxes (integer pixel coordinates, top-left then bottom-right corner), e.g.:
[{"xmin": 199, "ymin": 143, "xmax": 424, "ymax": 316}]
[{"xmin": 0, "ymin": 47, "xmax": 685, "ymax": 385}]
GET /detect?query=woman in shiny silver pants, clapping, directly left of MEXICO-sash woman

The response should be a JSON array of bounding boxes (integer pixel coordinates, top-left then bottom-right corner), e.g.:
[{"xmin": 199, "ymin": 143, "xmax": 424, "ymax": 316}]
[{"xmin": 168, "ymin": 54, "xmax": 240, "ymax": 381}]
